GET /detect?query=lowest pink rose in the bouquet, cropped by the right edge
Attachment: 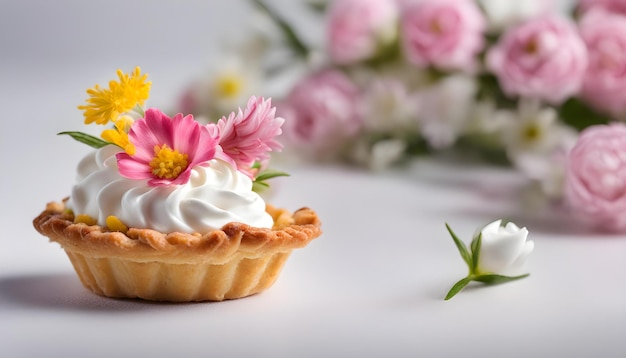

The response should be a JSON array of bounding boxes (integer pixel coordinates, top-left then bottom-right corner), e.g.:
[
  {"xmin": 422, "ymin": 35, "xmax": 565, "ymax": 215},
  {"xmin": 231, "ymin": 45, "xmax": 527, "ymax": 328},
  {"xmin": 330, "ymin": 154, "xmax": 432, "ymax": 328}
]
[{"xmin": 565, "ymin": 123, "xmax": 626, "ymax": 231}]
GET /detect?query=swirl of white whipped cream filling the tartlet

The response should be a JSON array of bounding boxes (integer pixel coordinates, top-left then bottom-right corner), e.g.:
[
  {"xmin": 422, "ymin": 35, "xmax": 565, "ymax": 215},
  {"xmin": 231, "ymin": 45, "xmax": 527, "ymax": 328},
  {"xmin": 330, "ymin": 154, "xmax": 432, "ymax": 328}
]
[{"xmin": 67, "ymin": 145, "xmax": 273, "ymax": 233}]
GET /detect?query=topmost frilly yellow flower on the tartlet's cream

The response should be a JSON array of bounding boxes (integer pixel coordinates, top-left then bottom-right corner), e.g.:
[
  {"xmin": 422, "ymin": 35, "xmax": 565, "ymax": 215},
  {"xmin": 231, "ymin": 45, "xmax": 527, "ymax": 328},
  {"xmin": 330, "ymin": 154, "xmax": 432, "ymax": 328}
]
[{"xmin": 78, "ymin": 67, "xmax": 152, "ymax": 124}]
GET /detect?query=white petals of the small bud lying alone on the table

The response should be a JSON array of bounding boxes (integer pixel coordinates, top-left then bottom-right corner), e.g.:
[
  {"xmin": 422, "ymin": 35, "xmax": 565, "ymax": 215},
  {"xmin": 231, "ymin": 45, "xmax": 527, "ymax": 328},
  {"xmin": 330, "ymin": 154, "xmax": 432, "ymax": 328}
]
[{"xmin": 477, "ymin": 220, "xmax": 534, "ymax": 275}]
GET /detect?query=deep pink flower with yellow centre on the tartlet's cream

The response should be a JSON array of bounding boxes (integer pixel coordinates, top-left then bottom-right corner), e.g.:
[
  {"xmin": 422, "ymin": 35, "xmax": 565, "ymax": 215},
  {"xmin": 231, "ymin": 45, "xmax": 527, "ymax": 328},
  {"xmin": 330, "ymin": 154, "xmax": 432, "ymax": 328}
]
[{"xmin": 116, "ymin": 108, "xmax": 219, "ymax": 186}]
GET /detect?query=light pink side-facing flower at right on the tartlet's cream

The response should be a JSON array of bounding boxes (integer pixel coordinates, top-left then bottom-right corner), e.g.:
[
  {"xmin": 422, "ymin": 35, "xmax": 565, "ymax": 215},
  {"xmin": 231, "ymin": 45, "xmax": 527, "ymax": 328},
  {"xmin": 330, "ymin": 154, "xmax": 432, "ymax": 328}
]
[{"xmin": 217, "ymin": 96, "xmax": 285, "ymax": 177}]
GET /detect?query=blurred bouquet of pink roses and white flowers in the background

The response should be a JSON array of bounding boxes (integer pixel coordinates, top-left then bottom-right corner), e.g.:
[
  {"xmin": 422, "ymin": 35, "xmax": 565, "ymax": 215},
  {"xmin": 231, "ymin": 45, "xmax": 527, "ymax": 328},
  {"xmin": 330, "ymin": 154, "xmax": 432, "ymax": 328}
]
[{"xmin": 180, "ymin": 0, "xmax": 626, "ymax": 231}]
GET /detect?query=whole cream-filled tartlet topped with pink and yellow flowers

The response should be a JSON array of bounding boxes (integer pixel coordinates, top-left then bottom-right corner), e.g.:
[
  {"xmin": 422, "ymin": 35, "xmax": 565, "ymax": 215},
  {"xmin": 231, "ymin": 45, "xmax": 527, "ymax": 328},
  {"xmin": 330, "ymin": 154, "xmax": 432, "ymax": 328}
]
[{"xmin": 33, "ymin": 68, "xmax": 321, "ymax": 302}]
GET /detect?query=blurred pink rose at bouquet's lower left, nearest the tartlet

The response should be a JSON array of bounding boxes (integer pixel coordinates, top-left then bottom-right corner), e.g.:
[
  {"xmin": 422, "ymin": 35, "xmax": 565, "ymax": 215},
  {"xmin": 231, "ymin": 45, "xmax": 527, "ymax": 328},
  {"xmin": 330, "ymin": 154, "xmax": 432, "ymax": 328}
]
[{"xmin": 277, "ymin": 71, "xmax": 362, "ymax": 157}]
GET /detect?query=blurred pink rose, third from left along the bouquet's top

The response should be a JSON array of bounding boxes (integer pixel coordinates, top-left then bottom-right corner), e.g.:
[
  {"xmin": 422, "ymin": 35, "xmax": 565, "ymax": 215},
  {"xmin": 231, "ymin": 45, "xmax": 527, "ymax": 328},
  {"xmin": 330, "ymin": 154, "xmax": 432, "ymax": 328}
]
[{"xmin": 487, "ymin": 16, "xmax": 587, "ymax": 104}]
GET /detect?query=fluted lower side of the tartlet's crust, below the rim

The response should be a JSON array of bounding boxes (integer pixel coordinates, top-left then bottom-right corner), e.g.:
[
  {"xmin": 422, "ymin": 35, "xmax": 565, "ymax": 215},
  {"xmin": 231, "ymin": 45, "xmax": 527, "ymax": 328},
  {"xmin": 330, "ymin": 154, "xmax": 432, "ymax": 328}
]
[{"xmin": 62, "ymin": 251, "xmax": 290, "ymax": 302}]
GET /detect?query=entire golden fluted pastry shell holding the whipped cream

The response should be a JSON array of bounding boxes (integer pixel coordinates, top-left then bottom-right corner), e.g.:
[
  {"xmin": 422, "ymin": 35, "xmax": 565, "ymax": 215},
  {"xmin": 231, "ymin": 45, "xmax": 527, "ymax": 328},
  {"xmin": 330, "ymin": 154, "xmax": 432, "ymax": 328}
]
[{"xmin": 33, "ymin": 203, "xmax": 321, "ymax": 302}]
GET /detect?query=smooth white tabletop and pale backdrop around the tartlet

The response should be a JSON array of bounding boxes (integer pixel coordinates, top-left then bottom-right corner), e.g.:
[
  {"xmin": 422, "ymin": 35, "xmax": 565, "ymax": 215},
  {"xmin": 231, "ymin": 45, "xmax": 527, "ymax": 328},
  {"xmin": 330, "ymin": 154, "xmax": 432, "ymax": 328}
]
[{"xmin": 0, "ymin": 0, "xmax": 626, "ymax": 357}]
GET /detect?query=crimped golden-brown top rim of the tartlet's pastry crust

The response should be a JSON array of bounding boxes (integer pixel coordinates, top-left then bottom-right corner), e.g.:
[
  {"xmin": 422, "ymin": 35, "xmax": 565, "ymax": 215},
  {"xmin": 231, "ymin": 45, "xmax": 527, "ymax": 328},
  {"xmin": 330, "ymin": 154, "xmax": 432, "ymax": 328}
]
[{"xmin": 33, "ymin": 203, "xmax": 321, "ymax": 264}]
